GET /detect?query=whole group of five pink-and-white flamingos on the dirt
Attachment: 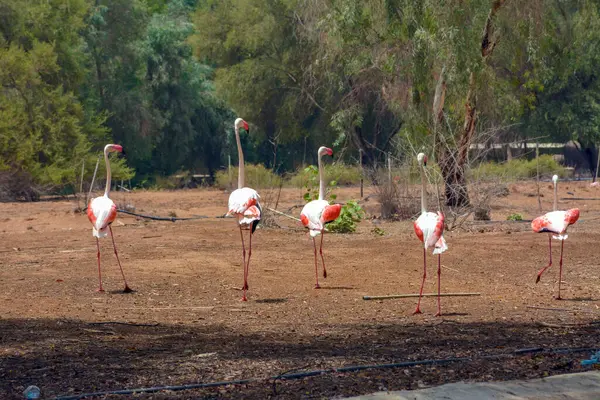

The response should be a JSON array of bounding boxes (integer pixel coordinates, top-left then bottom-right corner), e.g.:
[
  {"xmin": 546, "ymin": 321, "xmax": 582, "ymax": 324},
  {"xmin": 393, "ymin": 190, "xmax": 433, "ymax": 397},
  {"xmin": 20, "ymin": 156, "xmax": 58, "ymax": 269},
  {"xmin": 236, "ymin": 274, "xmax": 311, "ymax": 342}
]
[{"xmin": 82, "ymin": 118, "xmax": 579, "ymax": 316}]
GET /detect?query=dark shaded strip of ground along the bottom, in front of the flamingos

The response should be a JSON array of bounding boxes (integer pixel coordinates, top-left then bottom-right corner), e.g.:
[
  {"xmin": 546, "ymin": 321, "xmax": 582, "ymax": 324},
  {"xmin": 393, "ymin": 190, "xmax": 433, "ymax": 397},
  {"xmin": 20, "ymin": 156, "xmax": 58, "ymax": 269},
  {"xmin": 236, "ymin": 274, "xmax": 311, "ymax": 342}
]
[{"xmin": 0, "ymin": 318, "xmax": 598, "ymax": 399}]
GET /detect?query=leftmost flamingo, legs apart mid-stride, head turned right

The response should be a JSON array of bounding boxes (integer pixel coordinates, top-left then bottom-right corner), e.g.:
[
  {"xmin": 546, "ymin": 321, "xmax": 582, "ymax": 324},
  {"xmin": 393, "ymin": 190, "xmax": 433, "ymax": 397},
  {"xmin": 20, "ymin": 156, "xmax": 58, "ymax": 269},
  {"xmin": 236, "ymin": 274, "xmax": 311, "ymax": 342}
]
[{"xmin": 87, "ymin": 144, "xmax": 132, "ymax": 293}]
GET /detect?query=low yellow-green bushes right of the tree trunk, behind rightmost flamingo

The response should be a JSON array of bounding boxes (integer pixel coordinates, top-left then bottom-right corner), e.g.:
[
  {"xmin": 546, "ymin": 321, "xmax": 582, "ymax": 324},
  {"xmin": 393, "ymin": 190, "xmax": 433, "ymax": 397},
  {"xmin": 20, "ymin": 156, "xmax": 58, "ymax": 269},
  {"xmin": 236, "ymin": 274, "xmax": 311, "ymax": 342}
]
[{"xmin": 470, "ymin": 154, "xmax": 566, "ymax": 180}]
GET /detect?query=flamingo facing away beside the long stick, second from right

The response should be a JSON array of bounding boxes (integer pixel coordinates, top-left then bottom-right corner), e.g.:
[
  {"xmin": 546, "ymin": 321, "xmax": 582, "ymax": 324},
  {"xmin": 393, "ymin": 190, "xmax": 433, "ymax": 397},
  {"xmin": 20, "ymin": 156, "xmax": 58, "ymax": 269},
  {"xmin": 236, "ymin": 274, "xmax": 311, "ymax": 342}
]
[{"xmin": 413, "ymin": 153, "xmax": 448, "ymax": 317}]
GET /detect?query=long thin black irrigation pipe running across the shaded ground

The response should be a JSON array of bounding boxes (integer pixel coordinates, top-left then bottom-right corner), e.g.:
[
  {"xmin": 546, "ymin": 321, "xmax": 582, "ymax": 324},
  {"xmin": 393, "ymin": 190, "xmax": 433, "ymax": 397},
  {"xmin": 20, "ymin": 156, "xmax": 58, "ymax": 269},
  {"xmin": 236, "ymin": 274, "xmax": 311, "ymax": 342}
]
[{"xmin": 54, "ymin": 347, "xmax": 598, "ymax": 400}]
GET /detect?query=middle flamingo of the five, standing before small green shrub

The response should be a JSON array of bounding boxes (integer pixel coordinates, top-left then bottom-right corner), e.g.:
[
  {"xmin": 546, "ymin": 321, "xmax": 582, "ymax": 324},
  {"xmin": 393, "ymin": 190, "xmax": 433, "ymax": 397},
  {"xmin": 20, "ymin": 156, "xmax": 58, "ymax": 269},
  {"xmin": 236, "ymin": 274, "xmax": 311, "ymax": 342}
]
[{"xmin": 300, "ymin": 146, "xmax": 342, "ymax": 289}]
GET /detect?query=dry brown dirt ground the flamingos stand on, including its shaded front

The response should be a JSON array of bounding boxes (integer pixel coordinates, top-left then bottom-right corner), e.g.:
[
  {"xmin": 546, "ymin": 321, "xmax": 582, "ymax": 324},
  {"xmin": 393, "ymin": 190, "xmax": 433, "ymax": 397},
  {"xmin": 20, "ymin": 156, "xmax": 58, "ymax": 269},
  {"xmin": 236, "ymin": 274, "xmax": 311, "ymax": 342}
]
[{"xmin": 0, "ymin": 182, "xmax": 600, "ymax": 399}]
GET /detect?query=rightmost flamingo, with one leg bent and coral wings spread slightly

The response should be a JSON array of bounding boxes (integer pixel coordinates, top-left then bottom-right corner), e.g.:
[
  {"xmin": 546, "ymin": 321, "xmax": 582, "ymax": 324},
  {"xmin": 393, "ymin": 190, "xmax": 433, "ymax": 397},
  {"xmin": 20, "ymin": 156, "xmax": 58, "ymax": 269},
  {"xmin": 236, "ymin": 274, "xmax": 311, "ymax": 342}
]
[{"xmin": 531, "ymin": 175, "xmax": 579, "ymax": 300}]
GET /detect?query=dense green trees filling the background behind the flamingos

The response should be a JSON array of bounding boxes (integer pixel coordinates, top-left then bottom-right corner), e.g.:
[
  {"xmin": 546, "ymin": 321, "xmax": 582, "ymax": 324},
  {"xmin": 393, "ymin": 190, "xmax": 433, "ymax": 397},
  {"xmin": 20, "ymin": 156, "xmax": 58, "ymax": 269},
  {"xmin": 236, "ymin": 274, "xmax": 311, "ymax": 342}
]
[{"xmin": 0, "ymin": 0, "xmax": 600, "ymax": 200}]
